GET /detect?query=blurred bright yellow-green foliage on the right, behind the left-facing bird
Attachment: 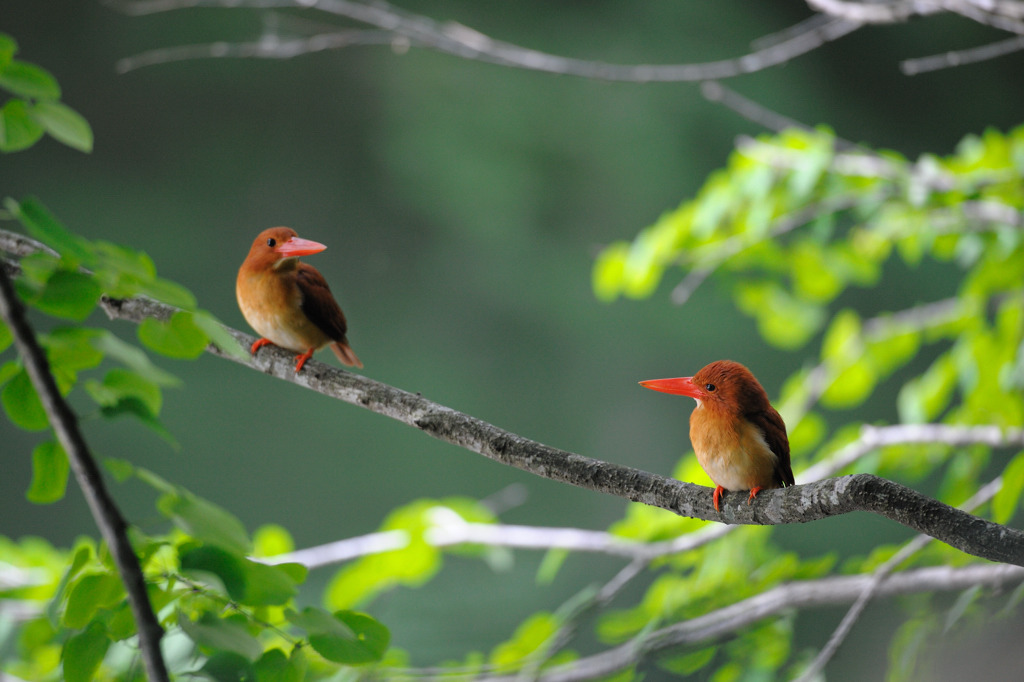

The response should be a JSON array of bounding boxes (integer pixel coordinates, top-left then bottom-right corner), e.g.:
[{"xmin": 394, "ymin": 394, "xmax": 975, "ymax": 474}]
[{"xmin": 593, "ymin": 122, "xmax": 1024, "ymax": 679}]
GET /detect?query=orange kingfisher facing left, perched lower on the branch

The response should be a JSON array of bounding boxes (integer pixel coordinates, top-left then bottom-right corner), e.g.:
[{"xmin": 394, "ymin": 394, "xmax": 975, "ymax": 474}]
[{"xmin": 640, "ymin": 360, "xmax": 795, "ymax": 511}]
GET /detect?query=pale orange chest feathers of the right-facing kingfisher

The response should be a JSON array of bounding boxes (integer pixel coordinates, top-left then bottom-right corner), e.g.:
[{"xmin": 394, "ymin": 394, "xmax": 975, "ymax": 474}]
[{"xmin": 236, "ymin": 270, "xmax": 328, "ymax": 352}]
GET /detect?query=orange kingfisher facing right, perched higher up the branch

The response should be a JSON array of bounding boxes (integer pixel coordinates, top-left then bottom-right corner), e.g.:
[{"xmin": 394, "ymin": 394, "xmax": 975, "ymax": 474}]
[{"xmin": 234, "ymin": 227, "xmax": 362, "ymax": 372}]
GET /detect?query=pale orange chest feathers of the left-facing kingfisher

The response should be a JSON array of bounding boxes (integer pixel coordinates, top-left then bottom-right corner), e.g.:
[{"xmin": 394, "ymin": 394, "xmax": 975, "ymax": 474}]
[{"xmin": 690, "ymin": 406, "xmax": 776, "ymax": 491}]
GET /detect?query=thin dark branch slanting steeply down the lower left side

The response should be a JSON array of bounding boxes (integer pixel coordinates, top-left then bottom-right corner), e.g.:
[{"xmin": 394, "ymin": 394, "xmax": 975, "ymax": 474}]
[{"xmin": 0, "ymin": 267, "xmax": 168, "ymax": 682}]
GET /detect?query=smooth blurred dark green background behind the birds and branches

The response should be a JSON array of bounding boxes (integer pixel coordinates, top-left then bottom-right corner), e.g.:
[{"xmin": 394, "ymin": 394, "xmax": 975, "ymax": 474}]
[{"xmin": 6, "ymin": 0, "xmax": 1024, "ymax": 679}]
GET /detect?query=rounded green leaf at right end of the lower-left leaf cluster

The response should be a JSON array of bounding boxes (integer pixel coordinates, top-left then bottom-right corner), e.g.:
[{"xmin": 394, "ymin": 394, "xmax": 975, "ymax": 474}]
[{"xmin": 285, "ymin": 606, "xmax": 391, "ymax": 665}]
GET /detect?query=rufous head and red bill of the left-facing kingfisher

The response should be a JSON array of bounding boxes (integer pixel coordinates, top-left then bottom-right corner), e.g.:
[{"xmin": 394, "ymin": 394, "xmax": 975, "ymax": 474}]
[{"xmin": 640, "ymin": 360, "xmax": 769, "ymax": 414}]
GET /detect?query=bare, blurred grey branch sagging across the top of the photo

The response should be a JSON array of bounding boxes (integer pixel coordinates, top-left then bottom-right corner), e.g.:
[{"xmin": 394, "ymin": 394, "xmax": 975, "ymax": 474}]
[{"xmin": 112, "ymin": 0, "xmax": 860, "ymax": 83}]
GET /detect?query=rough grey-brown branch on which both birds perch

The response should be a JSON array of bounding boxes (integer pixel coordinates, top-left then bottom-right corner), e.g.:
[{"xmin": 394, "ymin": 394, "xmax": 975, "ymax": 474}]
[{"xmin": 90, "ymin": 298, "xmax": 1024, "ymax": 565}]
